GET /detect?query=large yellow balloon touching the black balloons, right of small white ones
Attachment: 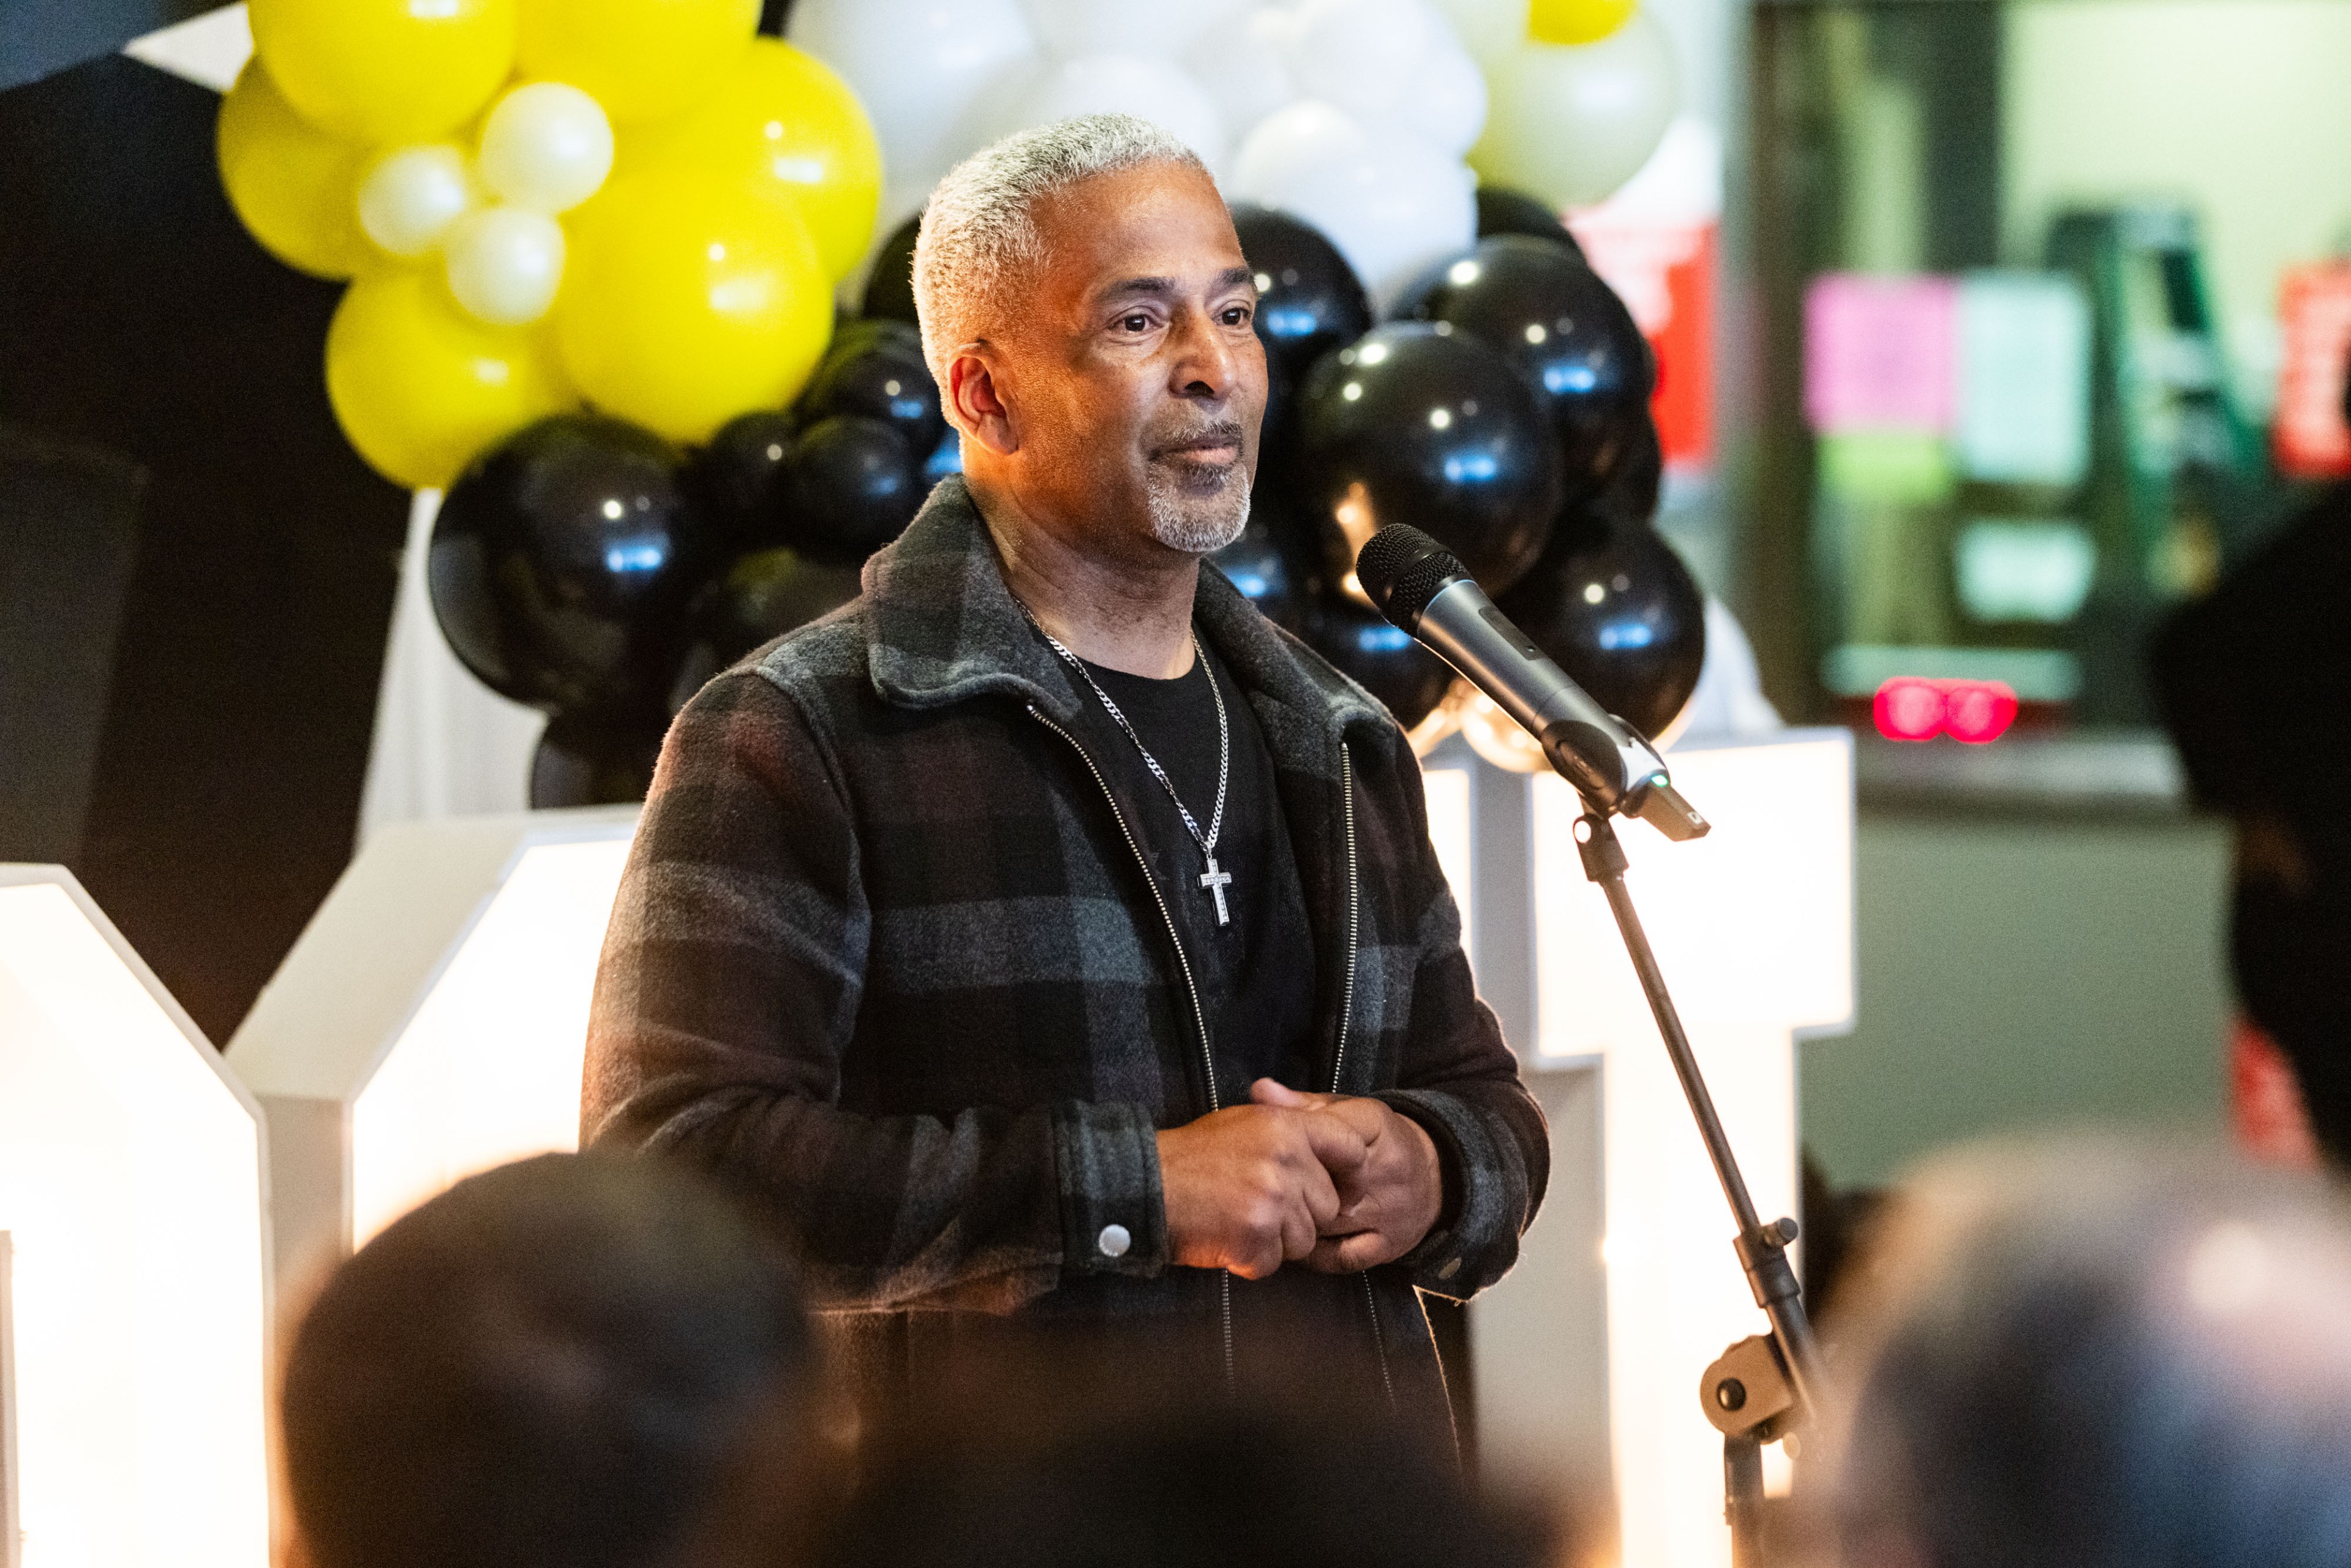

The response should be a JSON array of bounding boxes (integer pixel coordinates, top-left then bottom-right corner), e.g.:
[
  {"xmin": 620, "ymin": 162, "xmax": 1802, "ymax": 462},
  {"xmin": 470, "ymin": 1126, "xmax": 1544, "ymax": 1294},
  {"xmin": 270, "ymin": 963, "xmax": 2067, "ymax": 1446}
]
[{"xmin": 555, "ymin": 167, "xmax": 832, "ymax": 442}]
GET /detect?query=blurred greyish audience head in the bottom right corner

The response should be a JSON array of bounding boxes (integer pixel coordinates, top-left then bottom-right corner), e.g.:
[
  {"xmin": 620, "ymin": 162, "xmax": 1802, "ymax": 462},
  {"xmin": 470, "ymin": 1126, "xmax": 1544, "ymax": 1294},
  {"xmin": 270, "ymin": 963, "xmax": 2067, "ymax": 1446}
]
[{"xmin": 1824, "ymin": 1142, "xmax": 2351, "ymax": 1568}]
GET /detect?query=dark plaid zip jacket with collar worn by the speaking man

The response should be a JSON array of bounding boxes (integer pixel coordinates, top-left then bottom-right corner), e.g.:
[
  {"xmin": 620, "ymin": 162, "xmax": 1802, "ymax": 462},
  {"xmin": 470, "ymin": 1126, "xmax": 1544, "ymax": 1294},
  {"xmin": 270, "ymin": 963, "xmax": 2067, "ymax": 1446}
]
[{"xmin": 581, "ymin": 477, "xmax": 1549, "ymax": 1420}]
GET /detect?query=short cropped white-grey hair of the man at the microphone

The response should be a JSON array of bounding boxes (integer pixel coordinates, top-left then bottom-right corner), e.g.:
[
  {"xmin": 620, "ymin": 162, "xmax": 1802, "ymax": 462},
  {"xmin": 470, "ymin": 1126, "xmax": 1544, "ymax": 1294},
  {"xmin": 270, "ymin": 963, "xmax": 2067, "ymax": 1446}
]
[{"xmin": 914, "ymin": 115, "xmax": 1208, "ymax": 392}]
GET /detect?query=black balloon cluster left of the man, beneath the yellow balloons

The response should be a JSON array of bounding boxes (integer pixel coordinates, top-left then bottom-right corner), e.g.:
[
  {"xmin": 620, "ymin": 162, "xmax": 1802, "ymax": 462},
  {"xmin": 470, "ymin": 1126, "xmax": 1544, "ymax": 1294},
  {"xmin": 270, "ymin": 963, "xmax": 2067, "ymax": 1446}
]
[{"xmin": 426, "ymin": 322, "xmax": 955, "ymax": 806}]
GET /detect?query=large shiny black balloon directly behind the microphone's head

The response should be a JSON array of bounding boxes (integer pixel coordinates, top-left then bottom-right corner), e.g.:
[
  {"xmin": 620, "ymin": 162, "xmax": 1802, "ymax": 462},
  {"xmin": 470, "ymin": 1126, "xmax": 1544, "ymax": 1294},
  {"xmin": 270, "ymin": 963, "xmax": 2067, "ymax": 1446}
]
[{"xmin": 1293, "ymin": 322, "xmax": 1559, "ymax": 593}]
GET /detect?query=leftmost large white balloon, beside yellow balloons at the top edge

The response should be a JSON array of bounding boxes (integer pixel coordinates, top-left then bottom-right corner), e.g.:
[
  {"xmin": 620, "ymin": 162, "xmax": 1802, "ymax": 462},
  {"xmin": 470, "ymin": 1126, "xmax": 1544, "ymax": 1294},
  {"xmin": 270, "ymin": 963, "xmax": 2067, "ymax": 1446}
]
[{"xmin": 790, "ymin": 0, "xmax": 1037, "ymax": 190}]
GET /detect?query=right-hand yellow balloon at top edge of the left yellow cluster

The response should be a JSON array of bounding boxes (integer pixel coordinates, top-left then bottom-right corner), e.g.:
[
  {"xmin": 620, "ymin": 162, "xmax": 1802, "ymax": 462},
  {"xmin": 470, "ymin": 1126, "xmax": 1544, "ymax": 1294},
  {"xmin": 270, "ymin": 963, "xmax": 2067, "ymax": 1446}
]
[{"xmin": 522, "ymin": 0, "xmax": 759, "ymax": 122}]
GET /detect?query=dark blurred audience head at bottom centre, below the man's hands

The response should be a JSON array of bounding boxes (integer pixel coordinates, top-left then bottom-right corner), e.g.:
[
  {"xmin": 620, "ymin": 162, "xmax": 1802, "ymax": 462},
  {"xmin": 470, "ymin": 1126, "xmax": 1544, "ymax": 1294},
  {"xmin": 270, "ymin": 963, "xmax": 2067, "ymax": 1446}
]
[{"xmin": 825, "ymin": 1347, "xmax": 1559, "ymax": 1568}]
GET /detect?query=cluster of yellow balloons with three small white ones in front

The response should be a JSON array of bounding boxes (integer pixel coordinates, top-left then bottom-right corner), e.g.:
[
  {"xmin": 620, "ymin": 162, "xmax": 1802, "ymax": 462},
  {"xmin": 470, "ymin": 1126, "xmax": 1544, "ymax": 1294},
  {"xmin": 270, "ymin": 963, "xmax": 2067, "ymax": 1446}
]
[{"xmin": 219, "ymin": 0, "xmax": 882, "ymax": 487}]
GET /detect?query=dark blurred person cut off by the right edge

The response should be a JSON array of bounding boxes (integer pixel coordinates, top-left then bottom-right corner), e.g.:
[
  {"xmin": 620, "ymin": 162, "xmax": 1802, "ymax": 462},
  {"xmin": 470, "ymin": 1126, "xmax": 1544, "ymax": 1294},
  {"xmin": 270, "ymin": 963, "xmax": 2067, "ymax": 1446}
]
[{"xmin": 2151, "ymin": 373, "xmax": 2351, "ymax": 1168}]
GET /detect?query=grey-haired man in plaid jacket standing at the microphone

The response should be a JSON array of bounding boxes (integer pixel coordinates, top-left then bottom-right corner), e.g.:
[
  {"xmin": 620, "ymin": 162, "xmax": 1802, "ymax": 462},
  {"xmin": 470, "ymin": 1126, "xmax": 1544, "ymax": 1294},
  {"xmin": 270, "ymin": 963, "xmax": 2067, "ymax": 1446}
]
[{"xmin": 583, "ymin": 115, "xmax": 1549, "ymax": 1429}]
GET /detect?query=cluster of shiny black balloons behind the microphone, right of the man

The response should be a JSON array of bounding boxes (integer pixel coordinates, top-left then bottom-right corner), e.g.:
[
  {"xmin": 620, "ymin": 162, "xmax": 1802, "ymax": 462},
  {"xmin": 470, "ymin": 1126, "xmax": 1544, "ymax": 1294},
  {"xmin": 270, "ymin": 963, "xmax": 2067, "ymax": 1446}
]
[{"xmin": 1218, "ymin": 190, "xmax": 1704, "ymax": 771}]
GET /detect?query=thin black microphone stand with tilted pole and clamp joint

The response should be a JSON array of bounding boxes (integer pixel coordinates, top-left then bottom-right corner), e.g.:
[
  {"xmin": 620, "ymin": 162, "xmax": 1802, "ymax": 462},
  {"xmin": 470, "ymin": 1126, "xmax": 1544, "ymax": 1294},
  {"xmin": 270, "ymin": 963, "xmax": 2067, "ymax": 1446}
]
[{"xmin": 1575, "ymin": 795, "xmax": 1819, "ymax": 1568}]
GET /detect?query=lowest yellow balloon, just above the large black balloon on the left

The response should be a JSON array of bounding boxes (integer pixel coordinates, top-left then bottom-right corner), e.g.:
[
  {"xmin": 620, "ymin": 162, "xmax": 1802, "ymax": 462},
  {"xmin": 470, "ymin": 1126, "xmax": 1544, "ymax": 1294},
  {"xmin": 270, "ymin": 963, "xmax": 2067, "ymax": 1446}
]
[{"xmin": 327, "ymin": 268, "xmax": 578, "ymax": 489}]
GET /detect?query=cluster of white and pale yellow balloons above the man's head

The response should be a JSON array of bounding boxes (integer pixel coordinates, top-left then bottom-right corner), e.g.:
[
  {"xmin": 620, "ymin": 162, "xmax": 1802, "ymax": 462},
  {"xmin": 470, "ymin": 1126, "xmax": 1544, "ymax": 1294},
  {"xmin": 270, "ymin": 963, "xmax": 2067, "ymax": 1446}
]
[{"xmin": 790, "ymin": 0, "xmax": 1674, "ymax": 301}]
